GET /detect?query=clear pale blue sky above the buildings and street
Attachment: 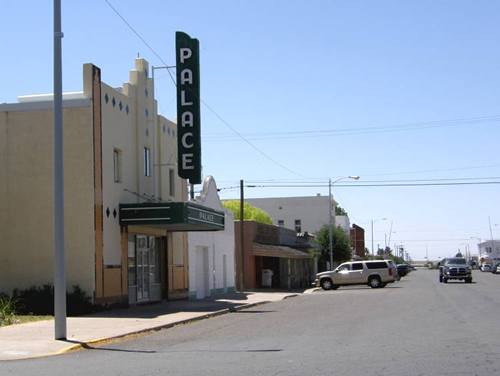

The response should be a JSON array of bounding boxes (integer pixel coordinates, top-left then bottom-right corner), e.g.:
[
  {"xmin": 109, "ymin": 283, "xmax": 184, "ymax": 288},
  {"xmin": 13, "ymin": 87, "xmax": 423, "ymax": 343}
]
[{"xmin": 0, "ymin": 0, "xmax": 500, "ymax": 260}]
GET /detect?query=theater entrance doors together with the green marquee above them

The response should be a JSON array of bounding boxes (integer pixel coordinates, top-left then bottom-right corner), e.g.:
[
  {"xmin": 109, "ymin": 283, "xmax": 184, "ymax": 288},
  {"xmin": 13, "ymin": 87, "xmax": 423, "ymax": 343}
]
[{"xmin": 120, "ymin": 202, "xmax": 224, "ymax": 304}]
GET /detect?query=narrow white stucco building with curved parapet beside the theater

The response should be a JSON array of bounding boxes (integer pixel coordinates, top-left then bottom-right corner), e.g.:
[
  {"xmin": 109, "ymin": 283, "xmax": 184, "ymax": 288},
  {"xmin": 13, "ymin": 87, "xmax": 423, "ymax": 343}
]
[{"xmin": 188, "ymin": 176, "xmax": 235, "ymax": 299}]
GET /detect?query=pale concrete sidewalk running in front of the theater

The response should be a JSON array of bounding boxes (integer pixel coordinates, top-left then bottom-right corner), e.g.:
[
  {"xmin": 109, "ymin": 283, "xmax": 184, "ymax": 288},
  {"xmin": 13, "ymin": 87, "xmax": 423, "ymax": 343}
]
[{"xmin": 0, "ymin": 292, "xmax": 297, "ymax": 360}]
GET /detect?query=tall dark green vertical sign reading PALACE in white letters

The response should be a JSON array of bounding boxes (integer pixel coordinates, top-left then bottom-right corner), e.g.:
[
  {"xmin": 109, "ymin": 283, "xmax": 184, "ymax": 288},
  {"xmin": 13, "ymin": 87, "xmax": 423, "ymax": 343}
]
[{"xmin": 175, "ymin": 31, "xmax": 201, "ymax": 184}]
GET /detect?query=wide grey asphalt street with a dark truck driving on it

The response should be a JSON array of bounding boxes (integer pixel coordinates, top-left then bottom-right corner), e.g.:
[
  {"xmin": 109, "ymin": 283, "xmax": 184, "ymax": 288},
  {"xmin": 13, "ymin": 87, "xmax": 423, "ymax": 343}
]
[{"xmin": 0, "ymin": 269, "xmax": 500, "ymax": 376}]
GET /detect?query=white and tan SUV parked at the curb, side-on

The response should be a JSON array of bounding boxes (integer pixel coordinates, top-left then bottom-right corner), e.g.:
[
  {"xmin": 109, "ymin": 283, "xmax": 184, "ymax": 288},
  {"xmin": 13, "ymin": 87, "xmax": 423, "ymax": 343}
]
[{"xmin": 315, "ymin": 260, "xmax": 396, "ymax": 290}]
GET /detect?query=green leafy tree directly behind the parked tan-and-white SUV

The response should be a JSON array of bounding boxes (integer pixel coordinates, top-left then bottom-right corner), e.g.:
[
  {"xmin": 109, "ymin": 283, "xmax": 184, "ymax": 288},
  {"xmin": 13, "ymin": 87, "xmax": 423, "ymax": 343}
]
[{"xmin": 315, "ymin": 225, "xmax": 351, "ymax": 270}]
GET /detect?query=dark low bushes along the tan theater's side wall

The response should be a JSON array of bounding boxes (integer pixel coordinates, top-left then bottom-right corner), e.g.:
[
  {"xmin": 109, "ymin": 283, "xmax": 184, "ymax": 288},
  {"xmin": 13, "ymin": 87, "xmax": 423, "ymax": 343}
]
[{"xmin": 13, "ymin": 284, "xmax": 96, "ymax": 316}]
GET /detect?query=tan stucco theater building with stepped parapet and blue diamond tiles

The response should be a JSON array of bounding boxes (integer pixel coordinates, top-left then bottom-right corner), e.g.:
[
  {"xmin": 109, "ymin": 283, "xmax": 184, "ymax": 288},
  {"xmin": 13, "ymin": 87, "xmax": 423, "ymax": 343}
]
[{"xmin": 0, "ymin": 59, "xmax": 223, "ymax": 303}]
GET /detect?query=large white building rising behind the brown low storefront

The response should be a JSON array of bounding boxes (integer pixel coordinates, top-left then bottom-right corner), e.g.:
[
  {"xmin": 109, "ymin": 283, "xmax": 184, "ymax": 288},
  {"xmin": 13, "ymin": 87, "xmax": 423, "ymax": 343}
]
[{"xmin": 245, "ymin": 195, "xmax": 350, "ymax": 234}]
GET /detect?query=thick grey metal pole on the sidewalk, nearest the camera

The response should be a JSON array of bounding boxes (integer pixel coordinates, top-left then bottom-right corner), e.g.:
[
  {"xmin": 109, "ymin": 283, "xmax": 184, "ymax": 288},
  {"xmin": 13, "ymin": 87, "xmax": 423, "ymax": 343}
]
[{"xmin": 54, "ymin": 0, "xmax": 66, "ymax": 340}]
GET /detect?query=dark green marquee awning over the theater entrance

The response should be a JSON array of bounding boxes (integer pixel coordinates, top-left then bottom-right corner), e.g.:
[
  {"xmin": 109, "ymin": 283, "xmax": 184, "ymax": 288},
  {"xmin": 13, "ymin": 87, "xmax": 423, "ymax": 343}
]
[{"xmin": 120, "ymin": 202, "xmax": 225, "ymax": 231}]
